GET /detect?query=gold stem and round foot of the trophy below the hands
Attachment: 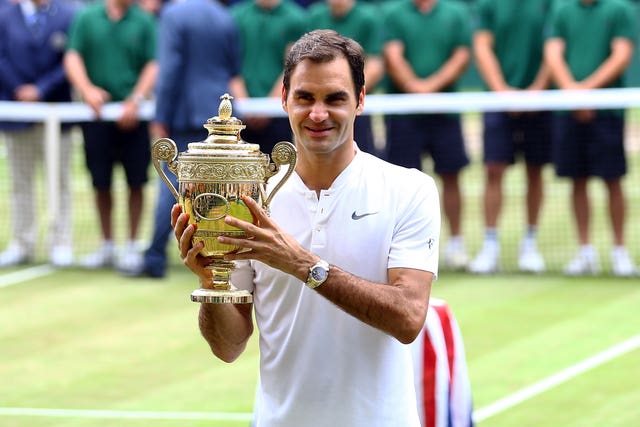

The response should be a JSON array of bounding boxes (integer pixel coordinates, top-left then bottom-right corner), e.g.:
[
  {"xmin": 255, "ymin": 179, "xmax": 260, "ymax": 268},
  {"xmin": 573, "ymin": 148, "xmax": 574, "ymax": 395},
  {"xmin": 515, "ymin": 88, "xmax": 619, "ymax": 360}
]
[{"xmin": 191, "ymin": 260, "xmax": 253, "ymax": 304}]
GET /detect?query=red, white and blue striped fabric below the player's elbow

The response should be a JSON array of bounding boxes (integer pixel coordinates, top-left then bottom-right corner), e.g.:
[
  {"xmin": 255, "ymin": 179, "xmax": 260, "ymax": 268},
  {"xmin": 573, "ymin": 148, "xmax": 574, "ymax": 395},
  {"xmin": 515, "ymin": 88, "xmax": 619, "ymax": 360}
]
[{"xmin": 411, "ymin": 298, "xmax": 473, "ymax": 427}]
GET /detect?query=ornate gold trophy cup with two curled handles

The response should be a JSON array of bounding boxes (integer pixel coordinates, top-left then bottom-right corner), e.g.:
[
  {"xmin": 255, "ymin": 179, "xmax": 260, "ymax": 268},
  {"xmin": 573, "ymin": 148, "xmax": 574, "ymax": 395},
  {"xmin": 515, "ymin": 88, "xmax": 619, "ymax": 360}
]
[{"xmin": 151, "ymin": 94, "xmax": 297, "ymax": 304}]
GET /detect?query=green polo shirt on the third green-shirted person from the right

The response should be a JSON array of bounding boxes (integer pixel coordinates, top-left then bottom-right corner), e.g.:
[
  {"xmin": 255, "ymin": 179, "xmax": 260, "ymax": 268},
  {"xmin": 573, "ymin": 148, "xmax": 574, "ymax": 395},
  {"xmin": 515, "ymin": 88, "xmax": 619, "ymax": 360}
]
[{"xmin": 384, "ymin": 0, "xmax": 471, "ymax": 93}]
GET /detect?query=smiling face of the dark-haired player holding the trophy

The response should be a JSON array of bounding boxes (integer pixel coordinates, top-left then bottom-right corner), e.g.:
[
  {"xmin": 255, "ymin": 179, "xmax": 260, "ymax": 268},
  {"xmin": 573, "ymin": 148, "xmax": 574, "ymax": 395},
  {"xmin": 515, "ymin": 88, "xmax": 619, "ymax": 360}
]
[{"xmin": 282, "ymin": 57, "xmax": 364, "ymax": 154}]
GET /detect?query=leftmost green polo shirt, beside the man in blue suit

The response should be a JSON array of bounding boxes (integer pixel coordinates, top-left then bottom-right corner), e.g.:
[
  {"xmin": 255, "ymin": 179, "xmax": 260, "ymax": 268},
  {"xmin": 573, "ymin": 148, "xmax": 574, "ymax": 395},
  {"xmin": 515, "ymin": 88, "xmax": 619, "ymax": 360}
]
[{"xmin": 67, "ymin": 2, "xmax": 156, "ymax": 101}]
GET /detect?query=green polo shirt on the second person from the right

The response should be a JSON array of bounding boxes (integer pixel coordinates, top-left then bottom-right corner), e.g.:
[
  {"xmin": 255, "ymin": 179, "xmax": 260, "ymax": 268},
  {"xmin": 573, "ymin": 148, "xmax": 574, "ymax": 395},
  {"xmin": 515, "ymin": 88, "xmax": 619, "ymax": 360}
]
[{"xmin": 476, "ymin": 0, "xmax": 552, "ymax": 88}]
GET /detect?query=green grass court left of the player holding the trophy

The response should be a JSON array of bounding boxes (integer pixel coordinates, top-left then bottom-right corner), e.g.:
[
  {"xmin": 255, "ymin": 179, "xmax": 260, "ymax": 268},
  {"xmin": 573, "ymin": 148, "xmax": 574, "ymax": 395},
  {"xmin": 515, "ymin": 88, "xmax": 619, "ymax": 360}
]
[{"xmin": 0, "ymin": 270, "xmax": 257, "ymax": 426}]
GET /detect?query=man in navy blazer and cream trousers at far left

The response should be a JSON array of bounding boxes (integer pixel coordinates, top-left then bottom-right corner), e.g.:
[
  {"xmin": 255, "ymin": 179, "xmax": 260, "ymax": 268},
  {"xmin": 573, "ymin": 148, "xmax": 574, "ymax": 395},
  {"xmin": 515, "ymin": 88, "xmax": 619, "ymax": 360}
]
[{"xmin": 0, "ymin": 0, "xmax": 73, "ymax": 267}]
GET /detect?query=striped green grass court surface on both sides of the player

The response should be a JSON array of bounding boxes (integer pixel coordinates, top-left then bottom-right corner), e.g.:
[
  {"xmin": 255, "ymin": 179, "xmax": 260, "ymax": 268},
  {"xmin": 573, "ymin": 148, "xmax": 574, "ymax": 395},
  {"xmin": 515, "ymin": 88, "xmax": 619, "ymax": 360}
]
[{"xmin": 0, "ymin": 267, "xmax": 640, "ymax": 427}]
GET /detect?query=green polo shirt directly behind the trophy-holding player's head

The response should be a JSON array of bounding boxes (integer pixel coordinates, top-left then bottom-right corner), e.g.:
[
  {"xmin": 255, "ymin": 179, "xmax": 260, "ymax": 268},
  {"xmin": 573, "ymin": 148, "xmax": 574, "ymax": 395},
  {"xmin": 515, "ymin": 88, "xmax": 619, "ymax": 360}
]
[{"xmin": 308, "ymin": 1, "xmax": 382, "ymax": 55}]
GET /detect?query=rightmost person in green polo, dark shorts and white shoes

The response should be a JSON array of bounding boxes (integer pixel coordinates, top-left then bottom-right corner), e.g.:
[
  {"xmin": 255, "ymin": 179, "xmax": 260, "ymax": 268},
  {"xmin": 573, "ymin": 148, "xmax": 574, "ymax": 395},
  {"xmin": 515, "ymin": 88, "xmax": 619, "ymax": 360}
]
[{"xmin": 545, "ymin": 0, "xmax": 638, "ymax": 276}]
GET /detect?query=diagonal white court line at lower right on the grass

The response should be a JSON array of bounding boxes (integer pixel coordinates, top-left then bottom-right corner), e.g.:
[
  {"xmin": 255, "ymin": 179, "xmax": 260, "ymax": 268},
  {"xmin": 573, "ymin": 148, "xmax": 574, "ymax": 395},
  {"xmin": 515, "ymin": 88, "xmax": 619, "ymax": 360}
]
[{"xmin": 473, "ymin": 335, "xmax": 640, "ymax": 423}]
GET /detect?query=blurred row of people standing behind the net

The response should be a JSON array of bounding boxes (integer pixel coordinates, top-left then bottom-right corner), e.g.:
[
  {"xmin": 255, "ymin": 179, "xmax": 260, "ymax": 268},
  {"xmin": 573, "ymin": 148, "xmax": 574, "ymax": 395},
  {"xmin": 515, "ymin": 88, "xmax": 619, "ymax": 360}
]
[{"xmin": 0, "ymin": 0, "xmax": 640, "ymax": 278}]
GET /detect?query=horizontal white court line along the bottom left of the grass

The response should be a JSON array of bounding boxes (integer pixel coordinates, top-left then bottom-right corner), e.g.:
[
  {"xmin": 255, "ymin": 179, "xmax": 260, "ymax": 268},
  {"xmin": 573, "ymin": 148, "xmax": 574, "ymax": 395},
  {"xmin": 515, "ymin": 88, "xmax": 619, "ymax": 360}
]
[{"xmin": 0, "ymin": 408, "xmax": 253, "ymax": 421}]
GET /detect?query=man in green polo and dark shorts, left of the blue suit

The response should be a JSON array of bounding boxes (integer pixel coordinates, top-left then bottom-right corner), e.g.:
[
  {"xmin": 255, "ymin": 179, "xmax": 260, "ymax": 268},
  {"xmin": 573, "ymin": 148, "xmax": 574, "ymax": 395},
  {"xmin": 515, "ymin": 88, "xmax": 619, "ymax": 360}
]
[{"xmin": 64, "ymin": 0, "xmax": 157, "ymax": 269}]
